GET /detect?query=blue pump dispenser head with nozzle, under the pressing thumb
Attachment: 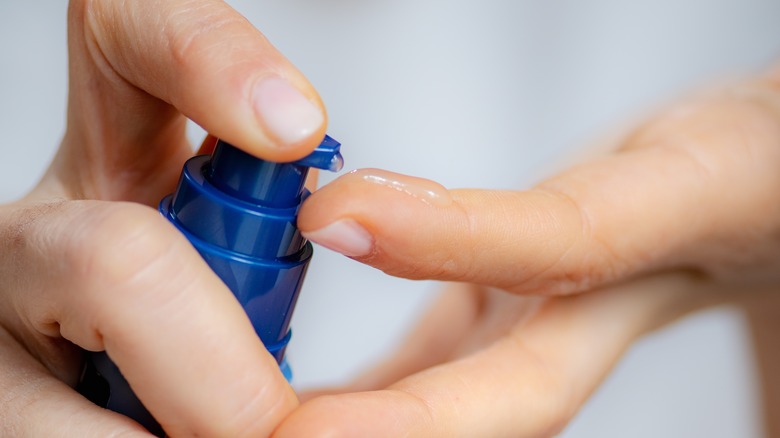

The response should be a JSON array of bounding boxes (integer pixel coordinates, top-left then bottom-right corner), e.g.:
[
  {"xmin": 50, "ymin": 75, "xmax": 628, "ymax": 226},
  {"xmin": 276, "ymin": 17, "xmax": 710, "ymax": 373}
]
[{"xmin": 165, "ymin": 137, "xmax": 343, "ymax": 261}]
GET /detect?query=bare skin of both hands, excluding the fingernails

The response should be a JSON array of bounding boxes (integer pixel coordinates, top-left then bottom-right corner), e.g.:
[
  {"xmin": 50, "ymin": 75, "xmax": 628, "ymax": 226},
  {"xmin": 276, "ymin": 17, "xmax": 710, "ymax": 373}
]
[{"xmin": 0, "ymin": 0, "xmax": 780, "ymax": 437}]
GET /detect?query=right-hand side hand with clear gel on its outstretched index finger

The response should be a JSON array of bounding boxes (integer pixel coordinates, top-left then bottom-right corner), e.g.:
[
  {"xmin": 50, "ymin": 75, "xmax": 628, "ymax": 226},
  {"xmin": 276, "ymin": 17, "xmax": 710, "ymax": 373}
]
[{"xmin": 278, "ymin": 72, "xmax": 780, "ymax": 437}]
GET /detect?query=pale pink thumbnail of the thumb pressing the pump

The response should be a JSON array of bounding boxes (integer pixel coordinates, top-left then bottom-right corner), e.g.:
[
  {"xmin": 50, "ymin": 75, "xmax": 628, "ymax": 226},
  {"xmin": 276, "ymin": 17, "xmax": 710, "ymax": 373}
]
[{"xmin": 252, "ymin": 77, "xmax": 325, "ymax": 144}]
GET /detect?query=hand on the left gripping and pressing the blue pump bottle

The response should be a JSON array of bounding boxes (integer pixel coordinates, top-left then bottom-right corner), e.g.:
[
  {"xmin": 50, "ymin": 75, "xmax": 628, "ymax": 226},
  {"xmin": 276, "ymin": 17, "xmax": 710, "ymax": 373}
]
[{"xmin": 0, "ymin": 0, "xmax": 326, "ymax": 437}]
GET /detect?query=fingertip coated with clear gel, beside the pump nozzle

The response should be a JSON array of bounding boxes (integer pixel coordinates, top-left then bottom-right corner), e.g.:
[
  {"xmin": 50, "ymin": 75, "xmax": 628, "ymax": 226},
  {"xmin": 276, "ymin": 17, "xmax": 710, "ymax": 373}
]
[{"xmin": 298, "ymin": 169, "xmax": 462, "ymax": 277}]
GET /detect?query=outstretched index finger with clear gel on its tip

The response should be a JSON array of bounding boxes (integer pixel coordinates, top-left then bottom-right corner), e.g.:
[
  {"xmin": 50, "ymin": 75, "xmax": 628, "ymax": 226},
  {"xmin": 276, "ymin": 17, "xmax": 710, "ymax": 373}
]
[{"xmin": 298, "ymin": 169, "xmax": 582, "ymax": 294}]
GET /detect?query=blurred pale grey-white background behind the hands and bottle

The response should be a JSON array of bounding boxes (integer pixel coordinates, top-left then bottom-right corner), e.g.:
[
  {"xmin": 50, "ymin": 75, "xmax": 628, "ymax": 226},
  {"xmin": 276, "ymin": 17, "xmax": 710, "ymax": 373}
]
[{"xmin": 0, "ymin": 0, "xmax": 780, "ymax": 437}]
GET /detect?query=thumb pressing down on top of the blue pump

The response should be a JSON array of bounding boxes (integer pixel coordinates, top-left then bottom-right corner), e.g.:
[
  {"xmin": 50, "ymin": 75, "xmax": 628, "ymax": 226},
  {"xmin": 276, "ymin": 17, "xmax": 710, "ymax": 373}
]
[{"xmin": 83, "ymin": 0, "xmax": 325, "ymax": 160}]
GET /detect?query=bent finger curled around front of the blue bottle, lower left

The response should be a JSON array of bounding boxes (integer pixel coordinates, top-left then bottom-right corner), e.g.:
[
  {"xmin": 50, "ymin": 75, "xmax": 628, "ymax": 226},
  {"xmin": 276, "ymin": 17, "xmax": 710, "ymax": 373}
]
[{"xmin": 3, "ymin": 201, "xmax": 297, "ymax": 436}]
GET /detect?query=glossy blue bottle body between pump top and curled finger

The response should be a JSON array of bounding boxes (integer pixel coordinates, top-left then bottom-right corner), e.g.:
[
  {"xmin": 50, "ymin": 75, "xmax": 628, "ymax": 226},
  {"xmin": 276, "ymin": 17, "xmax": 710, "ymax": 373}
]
[{"xmin": 160, "ymin": 152, "xmax": 312, "ymax": 364}]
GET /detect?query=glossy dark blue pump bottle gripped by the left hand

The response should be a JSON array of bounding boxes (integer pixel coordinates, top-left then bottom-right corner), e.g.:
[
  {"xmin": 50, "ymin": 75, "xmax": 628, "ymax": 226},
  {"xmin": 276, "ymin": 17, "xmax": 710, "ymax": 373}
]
[{"xmin": 77, "ymin": 136, "xmax": 343, "ymax": 436}]
